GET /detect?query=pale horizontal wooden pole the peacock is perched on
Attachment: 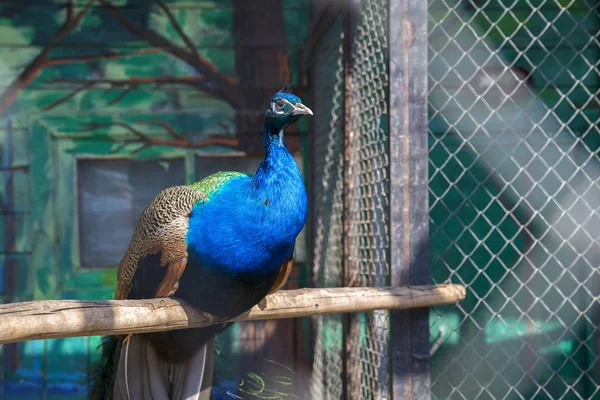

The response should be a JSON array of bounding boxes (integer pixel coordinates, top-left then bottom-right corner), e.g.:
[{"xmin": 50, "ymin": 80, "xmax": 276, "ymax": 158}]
[{"xmin": 0, "ymin": 285, "xmax": 465, "ymax": 344}]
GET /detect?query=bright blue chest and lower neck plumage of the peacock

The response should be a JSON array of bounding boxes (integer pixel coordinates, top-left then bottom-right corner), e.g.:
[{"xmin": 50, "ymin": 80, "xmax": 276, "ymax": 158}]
[{"xmin": 187, "ymin": 147, "xmax": 308, "ymax": 276}]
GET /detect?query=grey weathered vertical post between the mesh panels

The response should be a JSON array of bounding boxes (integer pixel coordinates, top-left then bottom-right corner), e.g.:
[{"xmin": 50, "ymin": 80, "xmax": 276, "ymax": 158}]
[{"xmin": 388, "ymin": 0, "xmax": 431, "ymax": 400}]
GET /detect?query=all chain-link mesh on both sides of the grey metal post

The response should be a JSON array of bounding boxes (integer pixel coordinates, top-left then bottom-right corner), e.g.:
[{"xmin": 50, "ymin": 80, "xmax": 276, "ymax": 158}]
[{"xmin": 311, "ymin": 0, "xmax": 600, "ymax": 400}]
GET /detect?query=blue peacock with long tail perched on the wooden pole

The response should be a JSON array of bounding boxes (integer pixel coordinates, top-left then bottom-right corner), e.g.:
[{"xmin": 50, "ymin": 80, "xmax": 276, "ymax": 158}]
[{"xmin": 91, "ymin": 85, "xmax": 312, "ymax": 400}]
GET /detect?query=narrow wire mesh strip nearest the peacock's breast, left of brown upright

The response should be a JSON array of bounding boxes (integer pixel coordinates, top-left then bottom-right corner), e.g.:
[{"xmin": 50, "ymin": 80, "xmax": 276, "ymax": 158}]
[{"xmin": 310, "ymin": 17, "xmax": 345, "ymax": 399}]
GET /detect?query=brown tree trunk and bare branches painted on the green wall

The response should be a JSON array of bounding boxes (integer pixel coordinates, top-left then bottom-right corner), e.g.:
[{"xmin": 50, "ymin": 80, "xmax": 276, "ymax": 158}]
[{"xmin": 0, "ymin": 0, "xmax": 297, "ymax": 153}]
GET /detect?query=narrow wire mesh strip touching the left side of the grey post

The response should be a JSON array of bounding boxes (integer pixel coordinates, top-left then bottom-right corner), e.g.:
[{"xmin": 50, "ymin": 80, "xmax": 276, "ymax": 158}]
[{"xmin": 345, "ymin": 0, "xmax": 390, "ymax": 399}]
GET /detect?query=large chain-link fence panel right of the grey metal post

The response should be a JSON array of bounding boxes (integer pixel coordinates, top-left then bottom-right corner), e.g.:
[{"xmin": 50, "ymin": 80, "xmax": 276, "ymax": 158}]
[{"xmin": 429, "ymin": 0, "xmax": 600, "ymax": 400}]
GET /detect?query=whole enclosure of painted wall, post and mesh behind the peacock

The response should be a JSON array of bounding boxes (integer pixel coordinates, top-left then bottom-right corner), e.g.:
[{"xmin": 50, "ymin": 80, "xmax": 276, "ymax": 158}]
[{"xmin": 0, "ymin": 0, "xmax": 600, "ymax": 400}]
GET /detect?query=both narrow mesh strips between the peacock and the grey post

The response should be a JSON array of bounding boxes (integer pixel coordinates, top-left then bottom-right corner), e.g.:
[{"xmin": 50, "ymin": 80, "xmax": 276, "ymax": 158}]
[{"xmin": 311, "ymin": 0, "xmax": 390, "ymax": 399}]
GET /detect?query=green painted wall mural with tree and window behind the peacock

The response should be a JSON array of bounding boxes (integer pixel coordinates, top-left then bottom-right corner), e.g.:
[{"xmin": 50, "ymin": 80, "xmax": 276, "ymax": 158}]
[{"xmin": 0, "ymin": 0, "xmax": 309, "ymax": 399}]
